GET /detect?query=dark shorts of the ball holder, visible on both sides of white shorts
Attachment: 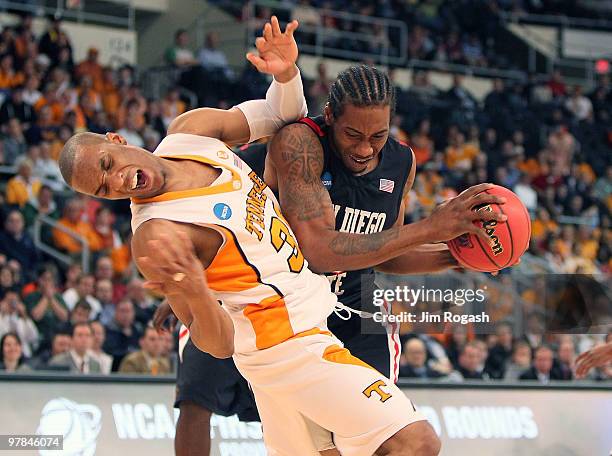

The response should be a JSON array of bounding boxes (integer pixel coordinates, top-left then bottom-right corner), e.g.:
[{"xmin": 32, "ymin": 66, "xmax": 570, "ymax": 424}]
[{"xmin": 174, "ymin": 318, "xmax": 400, "ymax": 421}]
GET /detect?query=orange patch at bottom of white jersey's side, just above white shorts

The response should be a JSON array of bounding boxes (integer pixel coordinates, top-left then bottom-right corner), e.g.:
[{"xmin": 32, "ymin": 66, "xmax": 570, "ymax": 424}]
[{"xmin": 242, "ymin": 294, "xmax": 295, "ymax": 350}]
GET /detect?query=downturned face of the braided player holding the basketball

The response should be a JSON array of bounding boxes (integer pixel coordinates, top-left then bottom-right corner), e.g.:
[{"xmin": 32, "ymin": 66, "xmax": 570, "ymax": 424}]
[{"xmin": 326, "ymin": 104, "xmax": 391, "ymax": 174}]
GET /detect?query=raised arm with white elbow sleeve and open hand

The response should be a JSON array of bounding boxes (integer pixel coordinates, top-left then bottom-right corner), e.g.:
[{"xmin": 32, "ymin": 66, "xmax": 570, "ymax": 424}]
[{"xmin": 168, "ymin": 16, "xmax": 307, "ymax": 144}]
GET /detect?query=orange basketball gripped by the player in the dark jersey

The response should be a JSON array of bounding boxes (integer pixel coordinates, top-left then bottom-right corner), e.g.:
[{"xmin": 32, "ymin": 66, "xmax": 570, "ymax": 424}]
[{"xmin": 448, "ymin": 185, "xmax": 531, "ymax": 272}]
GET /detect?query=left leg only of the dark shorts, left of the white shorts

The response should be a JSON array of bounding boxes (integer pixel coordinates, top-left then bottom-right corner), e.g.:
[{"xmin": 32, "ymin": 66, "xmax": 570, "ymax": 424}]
[{"xmin": 174, "ymin": 339, "xmax": 260, "ymax": 421}]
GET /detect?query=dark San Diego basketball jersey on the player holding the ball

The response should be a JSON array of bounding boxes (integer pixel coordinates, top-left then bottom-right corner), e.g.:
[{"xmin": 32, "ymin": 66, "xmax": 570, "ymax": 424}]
[{"xmin": 239, "ymin": 116, "xmax": 412, "ymax": 339}]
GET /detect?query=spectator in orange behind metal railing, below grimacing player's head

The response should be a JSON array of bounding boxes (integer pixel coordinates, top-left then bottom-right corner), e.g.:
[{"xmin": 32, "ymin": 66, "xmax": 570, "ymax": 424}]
[{"xmin": 53, "ymin": 199, "xmax": 100, "ymax": 254}]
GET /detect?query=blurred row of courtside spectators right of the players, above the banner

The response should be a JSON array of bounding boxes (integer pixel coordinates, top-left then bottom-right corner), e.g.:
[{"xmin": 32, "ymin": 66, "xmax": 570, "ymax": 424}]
[{"xmin": 400, "ymin": 323, "xmax": 612, "ymax": 384}]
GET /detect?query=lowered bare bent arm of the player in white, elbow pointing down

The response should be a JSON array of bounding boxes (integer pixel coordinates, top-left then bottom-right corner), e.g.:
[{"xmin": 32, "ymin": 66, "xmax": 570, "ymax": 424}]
[{"xmin": 132, "ymin": 223, "xmax": 234, "ymax": 358}]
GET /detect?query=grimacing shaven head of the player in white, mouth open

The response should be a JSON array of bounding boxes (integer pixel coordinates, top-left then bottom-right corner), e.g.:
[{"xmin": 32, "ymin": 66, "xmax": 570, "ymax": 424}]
[{"xmin": 72, "ymin": 136, "xmax": 164, "ymax": 199}]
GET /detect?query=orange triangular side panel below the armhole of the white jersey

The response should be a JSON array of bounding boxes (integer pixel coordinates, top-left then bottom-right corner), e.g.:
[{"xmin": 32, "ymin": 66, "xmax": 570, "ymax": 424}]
[{"xmin": 206, "ymin": 225, "xmax": 261, "ymax": 292}]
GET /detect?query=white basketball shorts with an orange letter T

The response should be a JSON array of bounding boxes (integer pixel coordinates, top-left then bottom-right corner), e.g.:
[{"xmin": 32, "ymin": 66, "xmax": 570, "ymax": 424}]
[{"xmin": 234, "ymin": 334, "xmax": 425, "ymax": 456}]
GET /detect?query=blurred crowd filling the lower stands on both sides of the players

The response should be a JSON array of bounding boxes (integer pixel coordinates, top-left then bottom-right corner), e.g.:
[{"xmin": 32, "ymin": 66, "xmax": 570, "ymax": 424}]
[{"xmin": 0, "ymin": 10, "xmax": 612, "ymax": 380}]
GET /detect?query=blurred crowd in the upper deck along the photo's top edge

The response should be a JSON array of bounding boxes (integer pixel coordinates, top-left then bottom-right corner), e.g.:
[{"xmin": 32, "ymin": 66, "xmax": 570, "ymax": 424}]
[{"xmin": 218, "ymin": 0, "xmax": 610, "ymax": 69}]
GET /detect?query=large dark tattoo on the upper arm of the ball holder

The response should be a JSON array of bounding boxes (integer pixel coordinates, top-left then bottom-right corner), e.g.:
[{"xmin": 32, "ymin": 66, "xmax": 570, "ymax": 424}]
[{"xmin": 273, "ymin": 125, "xmax": 331, "ymax": 221}]
